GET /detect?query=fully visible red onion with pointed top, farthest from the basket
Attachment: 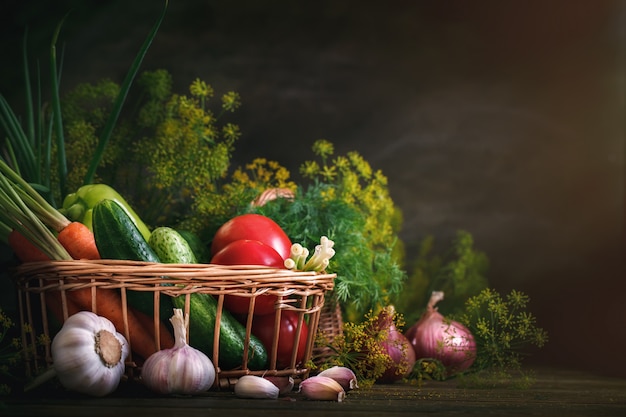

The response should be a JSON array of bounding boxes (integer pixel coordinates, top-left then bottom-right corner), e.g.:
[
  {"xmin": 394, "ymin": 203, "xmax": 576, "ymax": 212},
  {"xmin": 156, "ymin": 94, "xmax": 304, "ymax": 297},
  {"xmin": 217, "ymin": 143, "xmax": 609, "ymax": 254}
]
[{"xmin": 405, "ymin": 291, "xmax": 476, "ymax": 375}]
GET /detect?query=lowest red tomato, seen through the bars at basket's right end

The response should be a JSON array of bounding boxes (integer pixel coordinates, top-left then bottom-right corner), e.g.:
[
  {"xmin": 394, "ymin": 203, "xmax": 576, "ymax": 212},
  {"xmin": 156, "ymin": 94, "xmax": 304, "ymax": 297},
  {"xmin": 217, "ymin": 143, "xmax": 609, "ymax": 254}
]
[{"xmin": 252, "ymin": 310, "xmax": 309, "ymax": 368}]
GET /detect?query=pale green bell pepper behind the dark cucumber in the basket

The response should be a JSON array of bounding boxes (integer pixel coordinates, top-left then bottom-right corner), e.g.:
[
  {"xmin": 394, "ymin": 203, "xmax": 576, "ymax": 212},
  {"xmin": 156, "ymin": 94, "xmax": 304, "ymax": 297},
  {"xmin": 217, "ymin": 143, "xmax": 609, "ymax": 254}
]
[{"xmin": 59, "ymin": 184, "xmax": 151, "ymax": 242}]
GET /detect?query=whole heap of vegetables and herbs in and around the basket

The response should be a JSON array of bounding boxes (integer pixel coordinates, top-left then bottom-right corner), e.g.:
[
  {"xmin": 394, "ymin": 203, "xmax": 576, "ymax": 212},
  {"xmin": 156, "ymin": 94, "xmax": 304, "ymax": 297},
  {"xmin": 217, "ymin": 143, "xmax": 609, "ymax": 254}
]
[{"xmin": 0, "ymin": 2, "xmax": 547, "ymax": 396}]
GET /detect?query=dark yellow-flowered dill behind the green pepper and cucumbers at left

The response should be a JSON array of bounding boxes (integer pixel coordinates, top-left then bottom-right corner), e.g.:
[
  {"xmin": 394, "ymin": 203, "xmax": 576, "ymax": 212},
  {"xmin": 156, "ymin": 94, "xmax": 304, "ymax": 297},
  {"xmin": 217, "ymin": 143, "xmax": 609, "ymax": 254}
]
[{"xmin": 51, "ymin": 70, "xmax": 241, "ymax": 232}]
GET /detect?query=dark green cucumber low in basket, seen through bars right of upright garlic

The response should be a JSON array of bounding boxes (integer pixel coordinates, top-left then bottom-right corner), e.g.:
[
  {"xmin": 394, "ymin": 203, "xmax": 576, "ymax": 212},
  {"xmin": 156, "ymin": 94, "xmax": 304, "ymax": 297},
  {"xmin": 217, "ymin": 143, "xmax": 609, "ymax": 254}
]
[{"xmin": 172, "ymin": 293, "xmax": 268, "ymax": 370}]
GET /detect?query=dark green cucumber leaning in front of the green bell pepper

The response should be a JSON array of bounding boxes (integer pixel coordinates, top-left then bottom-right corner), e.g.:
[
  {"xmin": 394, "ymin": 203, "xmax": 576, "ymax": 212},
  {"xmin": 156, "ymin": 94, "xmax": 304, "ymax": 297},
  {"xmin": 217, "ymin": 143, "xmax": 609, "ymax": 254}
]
[{"xmin": 93, "ymin": 200, "xmax": 174, "ymax": 323}]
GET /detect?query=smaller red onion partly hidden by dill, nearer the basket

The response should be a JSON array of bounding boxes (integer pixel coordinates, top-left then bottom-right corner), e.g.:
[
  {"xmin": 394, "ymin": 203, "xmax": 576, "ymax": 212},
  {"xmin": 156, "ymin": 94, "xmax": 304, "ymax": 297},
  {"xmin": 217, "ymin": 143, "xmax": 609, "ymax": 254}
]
[{"xmin": 375, "ymin": 306, "xmax": 415, "ymax": 384}]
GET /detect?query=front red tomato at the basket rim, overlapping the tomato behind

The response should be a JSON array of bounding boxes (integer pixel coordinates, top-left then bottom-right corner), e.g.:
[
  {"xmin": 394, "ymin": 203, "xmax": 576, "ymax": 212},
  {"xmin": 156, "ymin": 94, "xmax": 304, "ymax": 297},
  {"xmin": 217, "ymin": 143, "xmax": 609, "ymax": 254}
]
[{"xmin": 211, "ymin": 240, "xmax": 284, "ymax": 315}]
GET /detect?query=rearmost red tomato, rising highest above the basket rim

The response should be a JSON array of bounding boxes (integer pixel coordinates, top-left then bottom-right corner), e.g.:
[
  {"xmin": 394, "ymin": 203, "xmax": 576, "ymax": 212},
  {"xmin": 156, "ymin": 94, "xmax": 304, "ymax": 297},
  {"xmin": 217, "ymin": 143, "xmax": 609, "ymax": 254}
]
[{"xmin": 211, "ymin": 213, "xmax": 291, "ymax": 259}]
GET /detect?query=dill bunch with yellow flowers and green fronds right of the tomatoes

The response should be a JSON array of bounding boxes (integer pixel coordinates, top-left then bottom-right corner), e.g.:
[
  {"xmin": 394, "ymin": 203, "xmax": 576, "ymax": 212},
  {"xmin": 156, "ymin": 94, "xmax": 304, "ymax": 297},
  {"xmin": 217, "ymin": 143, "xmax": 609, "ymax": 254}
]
[{"xmin": 239, "ymin": 140, "xmax": 406, "ymax": 321}]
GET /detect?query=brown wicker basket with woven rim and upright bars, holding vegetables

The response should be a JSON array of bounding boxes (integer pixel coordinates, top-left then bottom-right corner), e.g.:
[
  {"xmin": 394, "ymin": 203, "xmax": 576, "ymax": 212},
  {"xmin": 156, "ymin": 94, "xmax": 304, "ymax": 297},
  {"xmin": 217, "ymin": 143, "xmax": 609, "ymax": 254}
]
[{"xmin": 12, "ymin": 260, "xmax": 336, "ymax": 388}]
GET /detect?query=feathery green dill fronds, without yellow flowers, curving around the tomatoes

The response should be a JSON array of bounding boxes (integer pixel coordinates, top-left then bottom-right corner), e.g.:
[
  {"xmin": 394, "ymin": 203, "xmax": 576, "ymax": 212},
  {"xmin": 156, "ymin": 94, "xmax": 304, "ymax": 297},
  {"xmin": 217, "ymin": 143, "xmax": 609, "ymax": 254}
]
[{"xmin": 249, "ymin": 184, "xmax": 405, "ymax": 318}]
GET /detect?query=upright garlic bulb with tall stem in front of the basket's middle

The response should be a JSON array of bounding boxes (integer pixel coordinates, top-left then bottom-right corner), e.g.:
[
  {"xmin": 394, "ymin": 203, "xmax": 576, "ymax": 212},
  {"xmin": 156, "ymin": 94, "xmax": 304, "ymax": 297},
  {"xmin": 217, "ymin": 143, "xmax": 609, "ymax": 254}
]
[{"xmin": 141, "ymin": 308, "xmax": 215, "ymax": 395}]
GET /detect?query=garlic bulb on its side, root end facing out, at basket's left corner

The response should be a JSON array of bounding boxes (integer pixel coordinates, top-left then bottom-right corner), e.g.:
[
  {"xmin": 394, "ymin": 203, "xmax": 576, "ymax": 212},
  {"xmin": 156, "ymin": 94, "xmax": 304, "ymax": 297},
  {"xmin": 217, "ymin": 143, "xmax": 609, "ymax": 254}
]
[{"xmin": 51, "ymin": 311, "xmax": 129, "ymax": 397}]
